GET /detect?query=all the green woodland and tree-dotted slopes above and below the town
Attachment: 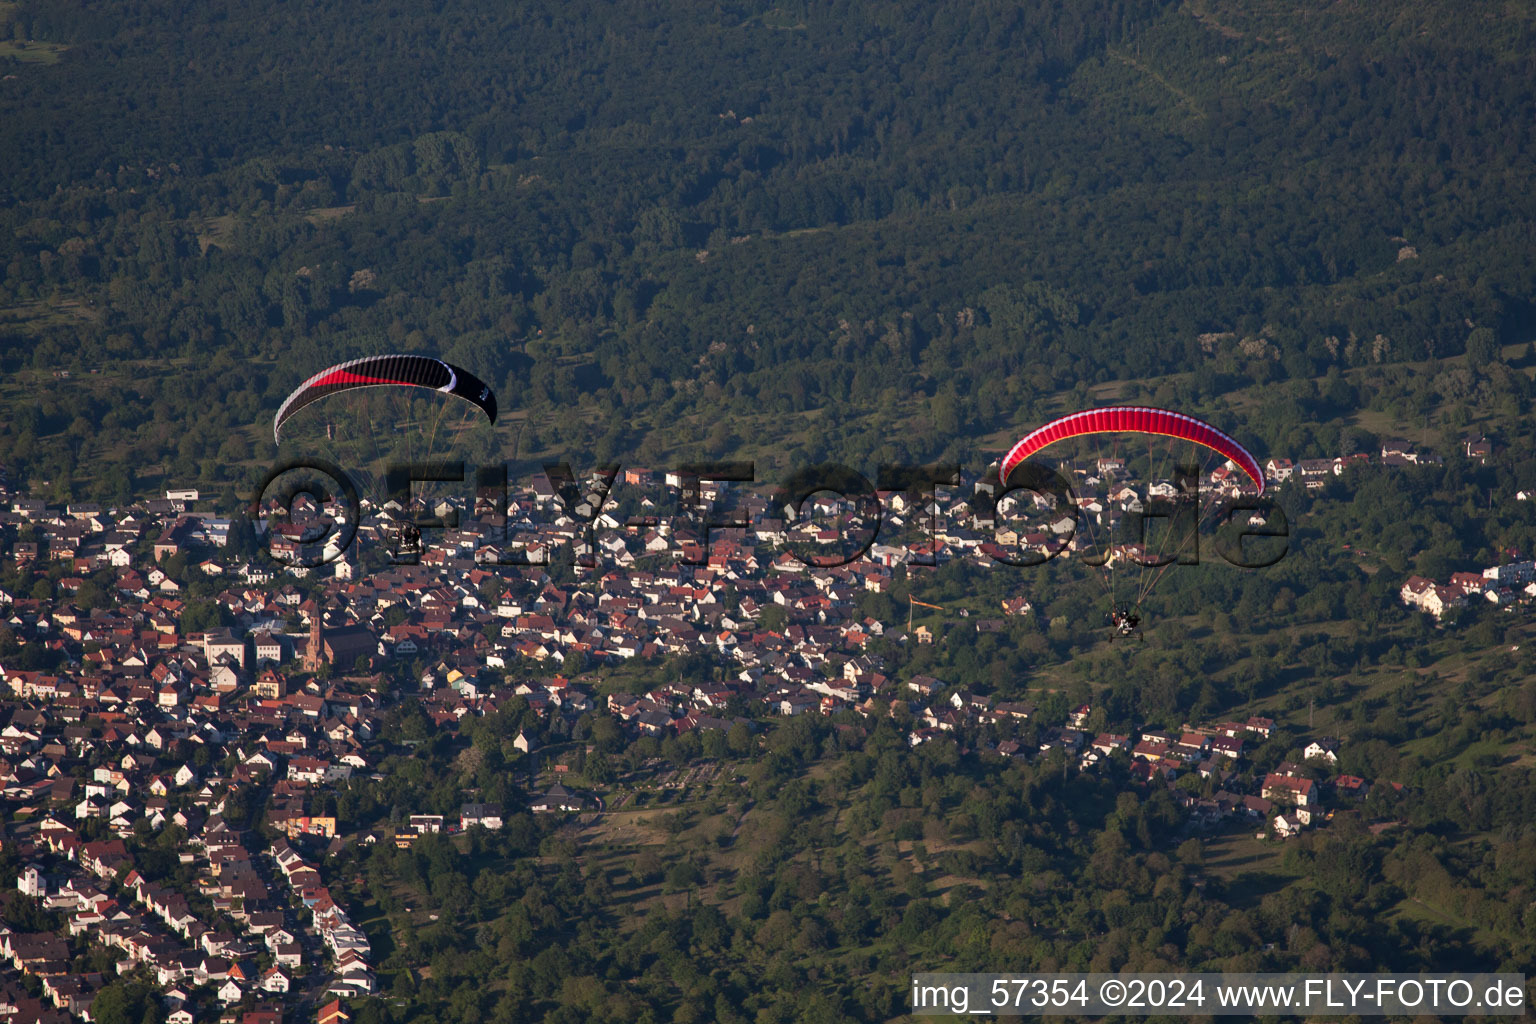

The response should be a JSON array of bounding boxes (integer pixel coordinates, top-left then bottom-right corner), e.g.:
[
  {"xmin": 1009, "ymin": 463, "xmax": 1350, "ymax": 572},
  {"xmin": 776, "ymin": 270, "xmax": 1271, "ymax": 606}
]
[{"xmin": 0, "ymin": 0, "xmax": 1536, "ymax": 1024}]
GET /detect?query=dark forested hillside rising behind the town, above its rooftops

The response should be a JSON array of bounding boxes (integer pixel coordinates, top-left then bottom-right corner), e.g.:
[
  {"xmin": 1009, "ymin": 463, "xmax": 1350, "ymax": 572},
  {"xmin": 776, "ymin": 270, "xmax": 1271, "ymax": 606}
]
[{"xmin": 0, "ymin": 0, "xmax": 1533, "ymax": 496}]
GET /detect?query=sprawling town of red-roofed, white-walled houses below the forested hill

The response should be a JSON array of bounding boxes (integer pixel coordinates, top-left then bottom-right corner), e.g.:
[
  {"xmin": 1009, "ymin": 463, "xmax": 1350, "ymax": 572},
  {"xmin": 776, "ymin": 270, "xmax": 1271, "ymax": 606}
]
[{"xmin": 0, "ymin": 445, "xmax": 1443, "ymax": 1024}]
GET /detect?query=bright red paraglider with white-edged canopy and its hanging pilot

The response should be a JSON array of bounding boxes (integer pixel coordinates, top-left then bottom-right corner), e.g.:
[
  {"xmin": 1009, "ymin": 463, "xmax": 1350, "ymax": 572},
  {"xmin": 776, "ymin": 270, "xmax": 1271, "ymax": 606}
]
[{"xmin": 998, "ymin": 405, "xmax": 1264, "ymax": 639}]
